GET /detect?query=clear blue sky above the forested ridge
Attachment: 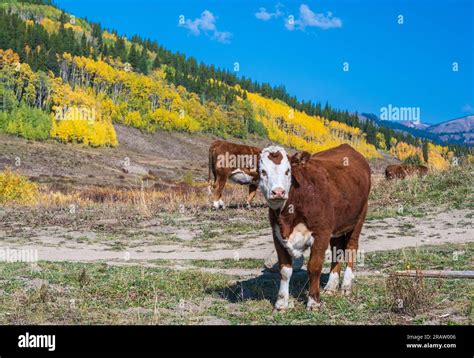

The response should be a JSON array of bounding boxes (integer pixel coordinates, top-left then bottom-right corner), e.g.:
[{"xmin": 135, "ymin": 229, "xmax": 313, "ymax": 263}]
[{"xmin": 55, "ymin": 0, "xmax": 474, "ymax": 123}]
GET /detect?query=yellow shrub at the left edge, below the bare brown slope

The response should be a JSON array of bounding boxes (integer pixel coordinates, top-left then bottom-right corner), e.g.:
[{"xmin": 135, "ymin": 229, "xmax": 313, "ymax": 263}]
[{"xmin": 0, "ymin": 169, "xmax": 38, "ymax": 204}]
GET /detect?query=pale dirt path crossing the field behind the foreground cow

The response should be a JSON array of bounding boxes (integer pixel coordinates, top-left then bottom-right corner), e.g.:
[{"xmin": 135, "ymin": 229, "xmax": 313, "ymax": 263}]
[{"xmin": 0, "ymin": 209, "xmax": 474, "ymax": 274}]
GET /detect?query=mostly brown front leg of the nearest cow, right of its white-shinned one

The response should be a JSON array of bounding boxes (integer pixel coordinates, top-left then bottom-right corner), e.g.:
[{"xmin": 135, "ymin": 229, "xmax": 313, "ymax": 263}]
[{"xmin": 306, "ymin": 234, "xmax": 330, "ymax": 311}]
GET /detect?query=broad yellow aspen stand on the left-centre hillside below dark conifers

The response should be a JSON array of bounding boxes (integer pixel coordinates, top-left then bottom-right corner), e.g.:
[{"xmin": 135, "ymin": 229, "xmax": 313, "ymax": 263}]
[{"xmin": 58, "ymin": 53, "xmax": 209, "ymax": 132}]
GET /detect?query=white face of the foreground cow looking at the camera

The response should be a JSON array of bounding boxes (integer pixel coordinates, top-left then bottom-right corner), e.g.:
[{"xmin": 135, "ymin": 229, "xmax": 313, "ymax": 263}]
[{"xmin": 259, "ymin": 146, "xmax": 291, "ymax": 210}]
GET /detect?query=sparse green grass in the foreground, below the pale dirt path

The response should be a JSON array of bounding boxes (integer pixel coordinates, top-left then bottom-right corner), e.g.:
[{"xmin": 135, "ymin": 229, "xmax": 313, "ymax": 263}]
[{"xmin": 0, "ymin": 243, "xmax": 474, "ymax": 325}]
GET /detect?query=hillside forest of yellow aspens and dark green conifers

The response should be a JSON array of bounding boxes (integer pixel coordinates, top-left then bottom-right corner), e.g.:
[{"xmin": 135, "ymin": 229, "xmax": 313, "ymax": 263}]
[{"xmin": 0, "ymin": 0, "xmax": 467, "ymax": 168}]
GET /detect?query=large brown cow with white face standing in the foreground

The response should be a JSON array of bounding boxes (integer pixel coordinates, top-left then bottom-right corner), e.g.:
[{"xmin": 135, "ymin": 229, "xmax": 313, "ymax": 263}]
[{"xmin": 259, "ymin": 144, "xmax": 370, "ymax": 310}]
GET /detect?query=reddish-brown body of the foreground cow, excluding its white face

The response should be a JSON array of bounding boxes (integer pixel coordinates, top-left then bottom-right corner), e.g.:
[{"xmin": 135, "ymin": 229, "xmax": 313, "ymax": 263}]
[{"xmin": 270, "ymin": 144, "xmax": 370, "ymax": 309}]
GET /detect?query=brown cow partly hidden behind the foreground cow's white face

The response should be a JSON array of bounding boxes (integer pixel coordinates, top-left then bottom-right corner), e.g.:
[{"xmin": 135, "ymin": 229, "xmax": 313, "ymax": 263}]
[{"xmin": 209, "ymin": 140, "xmax": 261, "ymax": 209}]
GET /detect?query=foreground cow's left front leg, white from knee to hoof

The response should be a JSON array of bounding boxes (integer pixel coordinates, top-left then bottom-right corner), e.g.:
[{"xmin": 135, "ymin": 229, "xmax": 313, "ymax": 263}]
[{"xmin": 273, "ymin": 226, "xmax": 293, "ymax": 311}]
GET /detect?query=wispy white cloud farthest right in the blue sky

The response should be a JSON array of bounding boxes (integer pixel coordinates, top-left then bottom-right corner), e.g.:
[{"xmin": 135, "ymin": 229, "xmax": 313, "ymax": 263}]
[{"xmin": 285, "ymin": 4, "xmax": 342, "ymax": 31}]
